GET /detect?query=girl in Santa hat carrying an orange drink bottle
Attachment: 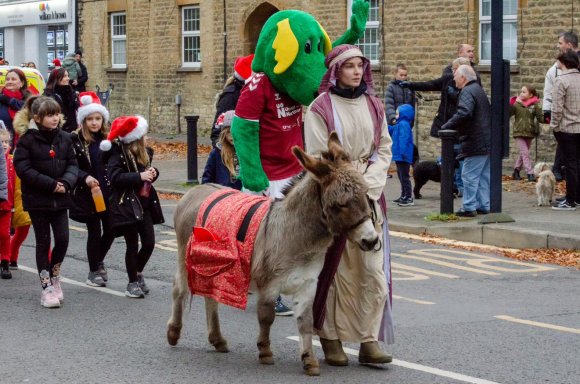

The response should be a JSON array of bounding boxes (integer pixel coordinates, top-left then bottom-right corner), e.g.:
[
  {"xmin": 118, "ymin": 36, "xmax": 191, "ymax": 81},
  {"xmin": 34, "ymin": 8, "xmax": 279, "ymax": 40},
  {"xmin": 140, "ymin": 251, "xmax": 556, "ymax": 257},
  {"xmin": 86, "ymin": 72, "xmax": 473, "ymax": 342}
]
[{"xmin": 69, "ymin": 92, "xmax": 115, "ymax": 287}]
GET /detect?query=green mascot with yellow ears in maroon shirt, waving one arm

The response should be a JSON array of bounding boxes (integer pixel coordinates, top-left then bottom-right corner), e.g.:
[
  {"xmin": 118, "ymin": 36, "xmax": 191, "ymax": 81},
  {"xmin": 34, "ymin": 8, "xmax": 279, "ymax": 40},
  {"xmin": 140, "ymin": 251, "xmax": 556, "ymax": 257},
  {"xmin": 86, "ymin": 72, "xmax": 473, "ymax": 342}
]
[{"xmin": 231, "ymin": 0, "xmax": 369, "ymax": 198}]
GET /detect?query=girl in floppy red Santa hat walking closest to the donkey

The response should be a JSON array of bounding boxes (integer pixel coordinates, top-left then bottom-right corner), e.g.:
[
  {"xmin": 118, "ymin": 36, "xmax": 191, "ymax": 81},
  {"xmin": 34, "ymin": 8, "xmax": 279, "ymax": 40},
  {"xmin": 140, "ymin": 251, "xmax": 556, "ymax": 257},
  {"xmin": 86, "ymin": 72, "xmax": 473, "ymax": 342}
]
[{"xmin": 100, "ymin": 116, "xmax": 164, "ymax": 298}]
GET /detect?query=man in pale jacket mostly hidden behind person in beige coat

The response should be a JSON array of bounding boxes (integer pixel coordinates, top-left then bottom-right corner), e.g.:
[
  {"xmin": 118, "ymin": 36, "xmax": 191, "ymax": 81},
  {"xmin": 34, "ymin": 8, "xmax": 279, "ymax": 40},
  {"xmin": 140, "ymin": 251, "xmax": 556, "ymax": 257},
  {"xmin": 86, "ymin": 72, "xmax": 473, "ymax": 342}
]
[{"xmin": 542, "ymin": 32, "xmax": 578, "ymax": 181}]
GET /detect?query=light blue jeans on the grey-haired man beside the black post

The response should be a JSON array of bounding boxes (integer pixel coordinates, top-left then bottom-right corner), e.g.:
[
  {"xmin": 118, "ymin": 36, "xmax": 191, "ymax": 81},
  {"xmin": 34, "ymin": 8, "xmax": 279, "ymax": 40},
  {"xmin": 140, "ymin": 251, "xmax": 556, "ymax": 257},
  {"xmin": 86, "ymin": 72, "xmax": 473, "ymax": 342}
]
[{"xmin": 461, "ymin": 155, "xmax": 490, "ymax": 211}]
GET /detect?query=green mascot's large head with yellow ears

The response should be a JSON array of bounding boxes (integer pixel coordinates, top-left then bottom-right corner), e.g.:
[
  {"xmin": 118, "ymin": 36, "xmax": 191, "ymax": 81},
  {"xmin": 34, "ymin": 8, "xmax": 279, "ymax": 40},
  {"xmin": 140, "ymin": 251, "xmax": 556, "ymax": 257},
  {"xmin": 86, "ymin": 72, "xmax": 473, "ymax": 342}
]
[{"xmin": 252, "ymin": 10, "xmax": 332, "ymax": 105}]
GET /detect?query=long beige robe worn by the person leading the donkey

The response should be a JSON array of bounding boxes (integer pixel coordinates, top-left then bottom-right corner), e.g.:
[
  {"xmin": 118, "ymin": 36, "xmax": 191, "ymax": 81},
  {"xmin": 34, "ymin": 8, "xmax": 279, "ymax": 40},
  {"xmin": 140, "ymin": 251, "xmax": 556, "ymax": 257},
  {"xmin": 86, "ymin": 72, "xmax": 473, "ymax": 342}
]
[{"xmin": 304, "ymin": 94, "xmax": 392, "ymax": 343}]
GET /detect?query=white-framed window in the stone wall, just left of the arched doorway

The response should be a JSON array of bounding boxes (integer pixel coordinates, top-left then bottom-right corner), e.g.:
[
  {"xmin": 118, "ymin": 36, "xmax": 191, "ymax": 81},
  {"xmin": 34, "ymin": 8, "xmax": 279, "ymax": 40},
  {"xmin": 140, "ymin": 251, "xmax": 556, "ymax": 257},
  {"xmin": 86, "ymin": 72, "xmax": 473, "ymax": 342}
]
[{"xmin": 181, "ymin": 6, "xmax": 201, "ymax": 67}]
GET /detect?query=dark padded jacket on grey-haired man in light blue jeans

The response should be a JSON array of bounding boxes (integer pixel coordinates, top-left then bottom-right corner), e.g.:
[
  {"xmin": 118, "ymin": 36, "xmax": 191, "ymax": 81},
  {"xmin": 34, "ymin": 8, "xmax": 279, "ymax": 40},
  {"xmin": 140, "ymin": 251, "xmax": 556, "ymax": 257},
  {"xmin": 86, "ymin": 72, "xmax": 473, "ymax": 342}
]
[{"xmin": 441, "ymin": 80, "xmax": 491, "ymax": 160}]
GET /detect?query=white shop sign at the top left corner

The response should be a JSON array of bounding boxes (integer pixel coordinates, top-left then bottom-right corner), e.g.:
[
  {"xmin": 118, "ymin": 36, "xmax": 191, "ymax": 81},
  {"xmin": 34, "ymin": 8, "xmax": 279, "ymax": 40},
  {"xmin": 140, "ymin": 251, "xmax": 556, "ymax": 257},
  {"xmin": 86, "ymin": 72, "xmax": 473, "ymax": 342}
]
[{"xmin": 0, "ymin": 0, "xmax": 72, "ymax": 28}]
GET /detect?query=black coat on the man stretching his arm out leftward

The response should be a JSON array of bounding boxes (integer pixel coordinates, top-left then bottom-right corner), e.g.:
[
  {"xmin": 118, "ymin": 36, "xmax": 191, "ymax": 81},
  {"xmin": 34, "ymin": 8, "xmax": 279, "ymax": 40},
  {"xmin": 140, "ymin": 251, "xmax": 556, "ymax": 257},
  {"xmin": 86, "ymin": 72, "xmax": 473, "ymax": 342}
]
[{"xmin": 408, "ymin": 64, "xmax": 481, "ymax": 138}]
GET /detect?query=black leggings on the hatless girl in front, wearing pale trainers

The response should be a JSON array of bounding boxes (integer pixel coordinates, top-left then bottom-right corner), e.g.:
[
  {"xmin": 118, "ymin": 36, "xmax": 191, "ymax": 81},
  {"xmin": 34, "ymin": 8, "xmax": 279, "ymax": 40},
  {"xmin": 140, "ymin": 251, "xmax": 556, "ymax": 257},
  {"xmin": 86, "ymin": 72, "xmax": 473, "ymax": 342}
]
[{"xmin": 28, "ymin": 209, "xmax": 68, "ymax": 277}]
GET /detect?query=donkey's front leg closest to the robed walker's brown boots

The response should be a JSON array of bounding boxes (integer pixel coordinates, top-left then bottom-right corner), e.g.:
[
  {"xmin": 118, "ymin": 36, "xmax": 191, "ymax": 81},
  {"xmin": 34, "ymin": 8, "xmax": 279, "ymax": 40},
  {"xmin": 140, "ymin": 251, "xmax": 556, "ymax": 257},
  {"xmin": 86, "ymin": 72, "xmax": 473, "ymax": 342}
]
[{"xmin": 293, "ymin": 279, "xmax": 320, "ymax": 376}]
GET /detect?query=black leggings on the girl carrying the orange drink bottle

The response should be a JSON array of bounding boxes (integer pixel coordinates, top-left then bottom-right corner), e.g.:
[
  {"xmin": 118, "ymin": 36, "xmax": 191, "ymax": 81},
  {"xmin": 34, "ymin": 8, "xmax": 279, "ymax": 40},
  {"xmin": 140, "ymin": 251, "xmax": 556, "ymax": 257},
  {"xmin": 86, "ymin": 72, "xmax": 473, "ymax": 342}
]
[{"xmin": 86, "ymin": 211, "xmax": 115, "ymax": 272}]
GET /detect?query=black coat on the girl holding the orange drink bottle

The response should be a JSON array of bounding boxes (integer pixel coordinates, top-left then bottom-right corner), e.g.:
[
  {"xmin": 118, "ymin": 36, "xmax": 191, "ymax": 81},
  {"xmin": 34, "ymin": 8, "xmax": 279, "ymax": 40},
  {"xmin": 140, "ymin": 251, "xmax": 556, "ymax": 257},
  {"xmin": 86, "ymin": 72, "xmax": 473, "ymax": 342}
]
[{"xmin": 69, "ymin": 131, "xmax": 111, "ymax": 223}]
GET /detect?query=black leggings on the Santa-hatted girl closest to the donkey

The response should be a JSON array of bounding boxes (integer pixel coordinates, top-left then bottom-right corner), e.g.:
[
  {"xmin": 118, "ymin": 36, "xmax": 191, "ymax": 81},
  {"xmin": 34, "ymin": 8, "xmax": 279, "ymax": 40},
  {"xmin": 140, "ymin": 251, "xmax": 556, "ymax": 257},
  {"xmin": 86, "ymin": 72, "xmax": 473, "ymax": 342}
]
[{"xmin": 123, "ymin": 210, "xmax": 155, "ymax": 283}]
